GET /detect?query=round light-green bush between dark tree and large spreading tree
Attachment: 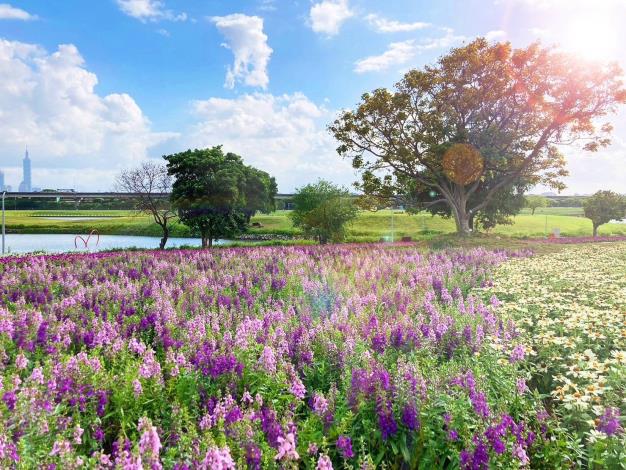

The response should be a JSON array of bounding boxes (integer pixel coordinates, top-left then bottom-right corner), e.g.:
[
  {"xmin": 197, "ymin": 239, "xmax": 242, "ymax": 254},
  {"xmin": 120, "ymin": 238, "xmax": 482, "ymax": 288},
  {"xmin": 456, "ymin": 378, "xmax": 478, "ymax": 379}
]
[{"xmin": 290, "ymin": 180, "xmax": 358, "ymax": 244}]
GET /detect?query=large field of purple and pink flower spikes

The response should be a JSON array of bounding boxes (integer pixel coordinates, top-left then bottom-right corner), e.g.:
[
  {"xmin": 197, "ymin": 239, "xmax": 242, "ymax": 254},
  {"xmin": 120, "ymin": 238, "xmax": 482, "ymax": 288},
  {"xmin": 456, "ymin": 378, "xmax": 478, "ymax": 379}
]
[{"xmin": 0, "ymin": 245, "xmax": 580, "ymax": 470}]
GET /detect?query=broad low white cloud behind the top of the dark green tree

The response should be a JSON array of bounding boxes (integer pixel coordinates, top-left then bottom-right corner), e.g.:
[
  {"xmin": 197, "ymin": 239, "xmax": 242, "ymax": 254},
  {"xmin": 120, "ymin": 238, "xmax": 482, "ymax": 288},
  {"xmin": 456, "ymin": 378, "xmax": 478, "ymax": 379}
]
[{"xmin": 185, "ymin": 93, "xmax": 354, "ymax": 191}]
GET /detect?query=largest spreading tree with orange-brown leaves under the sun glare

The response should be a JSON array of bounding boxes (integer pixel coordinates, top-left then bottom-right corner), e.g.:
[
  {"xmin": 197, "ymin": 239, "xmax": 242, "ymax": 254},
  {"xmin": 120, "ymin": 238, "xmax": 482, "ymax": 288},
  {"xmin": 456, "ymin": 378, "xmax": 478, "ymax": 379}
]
[{"xmin": 330, "ymin": 38, "xmax": 626, "ymax": 234}]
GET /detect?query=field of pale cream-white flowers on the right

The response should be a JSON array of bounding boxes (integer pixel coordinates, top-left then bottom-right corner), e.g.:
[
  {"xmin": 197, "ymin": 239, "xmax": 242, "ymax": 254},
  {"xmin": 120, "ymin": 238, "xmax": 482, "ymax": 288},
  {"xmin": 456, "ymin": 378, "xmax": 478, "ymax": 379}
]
[{"xmin": 476, "ymin": 243, "xmax": 626, "ymax": 468}]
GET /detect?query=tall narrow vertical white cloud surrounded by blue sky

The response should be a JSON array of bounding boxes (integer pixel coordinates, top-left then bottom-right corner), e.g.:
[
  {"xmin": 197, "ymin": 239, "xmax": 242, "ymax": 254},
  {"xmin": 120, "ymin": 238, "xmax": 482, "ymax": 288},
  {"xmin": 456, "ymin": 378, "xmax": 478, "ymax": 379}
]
[{"xmin": 211, "ymin": 13, "xmax": 273, "ymax": 88}]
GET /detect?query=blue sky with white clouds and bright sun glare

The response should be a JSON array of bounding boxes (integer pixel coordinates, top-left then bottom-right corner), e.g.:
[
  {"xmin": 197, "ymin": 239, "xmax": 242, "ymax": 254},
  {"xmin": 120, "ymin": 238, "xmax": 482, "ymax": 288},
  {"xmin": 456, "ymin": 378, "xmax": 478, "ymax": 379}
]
[{"xmin": 0, "ymin": 0, "xmax": 626, "ymax": 194}]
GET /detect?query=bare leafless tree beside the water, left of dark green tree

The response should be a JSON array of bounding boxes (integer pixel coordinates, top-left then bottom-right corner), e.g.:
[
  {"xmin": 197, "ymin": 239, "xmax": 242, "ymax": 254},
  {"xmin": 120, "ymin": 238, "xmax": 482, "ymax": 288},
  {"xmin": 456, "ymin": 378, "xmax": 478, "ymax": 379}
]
[{"xmin": 116, "ymin": 162, "xmax": 176, "ymax": 250}]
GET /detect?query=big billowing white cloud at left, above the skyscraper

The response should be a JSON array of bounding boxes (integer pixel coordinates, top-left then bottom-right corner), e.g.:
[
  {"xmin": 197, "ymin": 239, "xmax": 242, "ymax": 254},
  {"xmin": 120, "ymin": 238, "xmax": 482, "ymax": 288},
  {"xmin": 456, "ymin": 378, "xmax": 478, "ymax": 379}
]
[{"xmin": 0, "ymin": 39, "xmax": 173, "ymax": 189}]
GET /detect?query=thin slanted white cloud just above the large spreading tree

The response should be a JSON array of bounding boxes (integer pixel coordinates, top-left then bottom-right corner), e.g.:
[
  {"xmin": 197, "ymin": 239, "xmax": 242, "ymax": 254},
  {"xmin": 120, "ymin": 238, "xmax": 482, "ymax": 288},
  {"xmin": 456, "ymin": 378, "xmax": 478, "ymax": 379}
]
[{"xmin": 354, "ymin": 28, "xmax": 465, "ymax": 73}]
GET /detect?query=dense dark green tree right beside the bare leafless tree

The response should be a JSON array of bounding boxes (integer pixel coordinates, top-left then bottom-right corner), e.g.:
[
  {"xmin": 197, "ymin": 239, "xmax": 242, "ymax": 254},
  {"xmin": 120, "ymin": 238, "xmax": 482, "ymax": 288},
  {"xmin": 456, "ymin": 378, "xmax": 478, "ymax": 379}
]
[{"xmin": 163, "ymin": 146, "xmax": 276, "ymax": 248}]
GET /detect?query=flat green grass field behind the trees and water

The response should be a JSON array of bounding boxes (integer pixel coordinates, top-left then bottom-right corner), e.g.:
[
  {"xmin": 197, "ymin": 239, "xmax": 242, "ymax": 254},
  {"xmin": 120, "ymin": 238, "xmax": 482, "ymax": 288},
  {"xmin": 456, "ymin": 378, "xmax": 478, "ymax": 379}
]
[{"xmin": 6, "ymin": 207, "xmax": 626, "ymax": 242}]
